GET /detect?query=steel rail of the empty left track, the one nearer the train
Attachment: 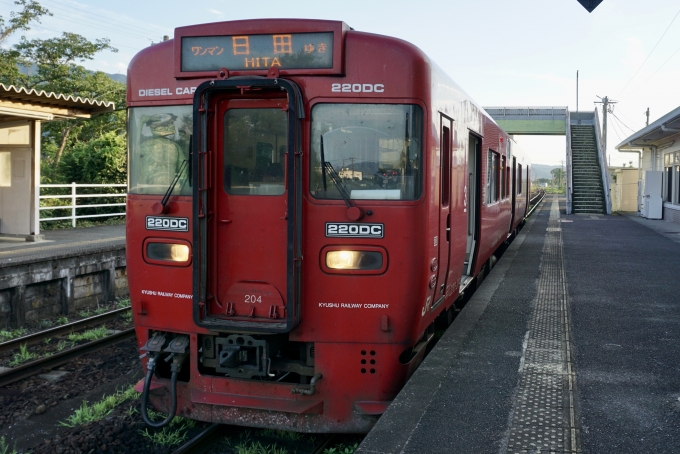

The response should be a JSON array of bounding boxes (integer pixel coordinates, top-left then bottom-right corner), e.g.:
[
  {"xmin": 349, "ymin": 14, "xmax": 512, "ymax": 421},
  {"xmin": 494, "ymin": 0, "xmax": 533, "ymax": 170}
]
[{"xmin": 0, "ymin": 328, "xmax": 135, "ymax": 387}]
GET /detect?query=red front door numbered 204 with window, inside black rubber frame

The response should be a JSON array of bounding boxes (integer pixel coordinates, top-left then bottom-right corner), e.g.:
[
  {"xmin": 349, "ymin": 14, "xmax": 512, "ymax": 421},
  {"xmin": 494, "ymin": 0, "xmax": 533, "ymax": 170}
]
[{"xmin": 208, "ymin": 96, "xmax": 289, "ymax": 326}]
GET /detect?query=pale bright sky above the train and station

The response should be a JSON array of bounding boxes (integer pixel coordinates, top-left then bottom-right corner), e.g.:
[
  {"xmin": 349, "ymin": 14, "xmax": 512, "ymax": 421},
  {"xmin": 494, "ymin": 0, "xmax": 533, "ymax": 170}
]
[{"xmin": 0, "ymin": 0, "xmax": 680, "ymax": 165}]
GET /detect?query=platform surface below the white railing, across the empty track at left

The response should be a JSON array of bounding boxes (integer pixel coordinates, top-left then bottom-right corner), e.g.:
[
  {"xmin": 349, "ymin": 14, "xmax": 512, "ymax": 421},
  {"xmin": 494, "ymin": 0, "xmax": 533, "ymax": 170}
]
[{"xmin": 0, "ymin": 224, "xmax": 125, "ymax": 267}]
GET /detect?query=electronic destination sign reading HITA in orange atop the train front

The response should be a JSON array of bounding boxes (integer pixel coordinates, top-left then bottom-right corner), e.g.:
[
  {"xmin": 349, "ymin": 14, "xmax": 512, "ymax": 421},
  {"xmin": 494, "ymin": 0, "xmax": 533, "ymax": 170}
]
[{"xmin": 182, "ymin": 32, "xmax": 333, "ymax": 72}]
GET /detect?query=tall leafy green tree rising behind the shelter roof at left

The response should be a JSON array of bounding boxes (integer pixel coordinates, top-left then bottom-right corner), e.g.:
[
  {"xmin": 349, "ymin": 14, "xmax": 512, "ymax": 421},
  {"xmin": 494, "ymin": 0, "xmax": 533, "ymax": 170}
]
[{"xmin": 0, "ymin": 0, "xmax": 126, "ymax": 177}]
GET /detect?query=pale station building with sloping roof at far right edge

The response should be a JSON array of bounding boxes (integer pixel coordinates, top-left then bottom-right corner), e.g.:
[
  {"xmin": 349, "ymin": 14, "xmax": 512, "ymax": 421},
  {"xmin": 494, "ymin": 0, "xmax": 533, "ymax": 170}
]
[{"xmin": 615, "ymin": 107, "xmax": 680, "ymax": 224}]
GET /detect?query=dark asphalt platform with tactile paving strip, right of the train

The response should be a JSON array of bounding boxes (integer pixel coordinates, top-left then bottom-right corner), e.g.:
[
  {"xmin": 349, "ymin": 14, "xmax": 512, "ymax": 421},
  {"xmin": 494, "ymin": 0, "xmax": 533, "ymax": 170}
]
[{"xmin": 356, "ymin": 195, "xmax": 680, "ymax": 453}]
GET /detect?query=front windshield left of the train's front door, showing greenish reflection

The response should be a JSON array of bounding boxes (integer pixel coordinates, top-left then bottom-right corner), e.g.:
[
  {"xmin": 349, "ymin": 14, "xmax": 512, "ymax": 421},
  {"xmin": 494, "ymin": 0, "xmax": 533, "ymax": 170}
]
[{"xmin": 128, "ymin": 105, "xmax": 192, "ymax": 195}]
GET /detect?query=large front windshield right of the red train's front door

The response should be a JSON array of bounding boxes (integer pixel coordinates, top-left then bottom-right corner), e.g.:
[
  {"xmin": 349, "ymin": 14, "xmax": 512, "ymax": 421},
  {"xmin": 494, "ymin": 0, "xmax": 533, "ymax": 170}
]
[{"xmin": 310, "ymin": 104, "xmax": 423, "ymax": 200}]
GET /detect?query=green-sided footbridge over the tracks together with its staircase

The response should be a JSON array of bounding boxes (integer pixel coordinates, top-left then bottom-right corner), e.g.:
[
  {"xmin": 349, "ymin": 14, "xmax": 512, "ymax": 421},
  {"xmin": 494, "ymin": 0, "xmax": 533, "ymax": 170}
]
[{"xmin": 484, "ymin": 107, "xmax": 611, "ymax": 214}]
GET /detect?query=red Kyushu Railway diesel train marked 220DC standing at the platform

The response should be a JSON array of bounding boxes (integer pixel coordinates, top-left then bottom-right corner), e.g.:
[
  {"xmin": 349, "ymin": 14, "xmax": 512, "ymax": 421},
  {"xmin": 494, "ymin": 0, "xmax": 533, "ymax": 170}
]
[{"xmin": 127, "ymin": 19, "xmax": 530, "ymax": 432}]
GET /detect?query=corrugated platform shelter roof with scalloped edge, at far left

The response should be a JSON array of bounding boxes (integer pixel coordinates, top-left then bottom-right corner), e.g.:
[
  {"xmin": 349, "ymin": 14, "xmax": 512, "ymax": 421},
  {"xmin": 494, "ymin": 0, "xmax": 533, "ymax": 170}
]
[{"xmin": 0, "ymin": 84, "xmax": 115, "ymax": 122}]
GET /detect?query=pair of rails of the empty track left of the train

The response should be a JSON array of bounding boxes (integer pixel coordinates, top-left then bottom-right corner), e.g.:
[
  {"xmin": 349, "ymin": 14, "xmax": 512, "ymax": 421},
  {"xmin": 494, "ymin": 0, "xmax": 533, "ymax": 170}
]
[{"xmin": 0, "ymin": 308, "xmax": 135, "ymax": 387}]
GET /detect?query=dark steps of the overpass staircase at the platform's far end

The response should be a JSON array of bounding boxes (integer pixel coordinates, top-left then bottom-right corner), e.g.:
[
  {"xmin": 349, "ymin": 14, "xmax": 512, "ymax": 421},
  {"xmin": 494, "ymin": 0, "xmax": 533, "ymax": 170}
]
[{"xmin": 570, "ymin": 124, "xmax": 607, "ymax": 214}]
